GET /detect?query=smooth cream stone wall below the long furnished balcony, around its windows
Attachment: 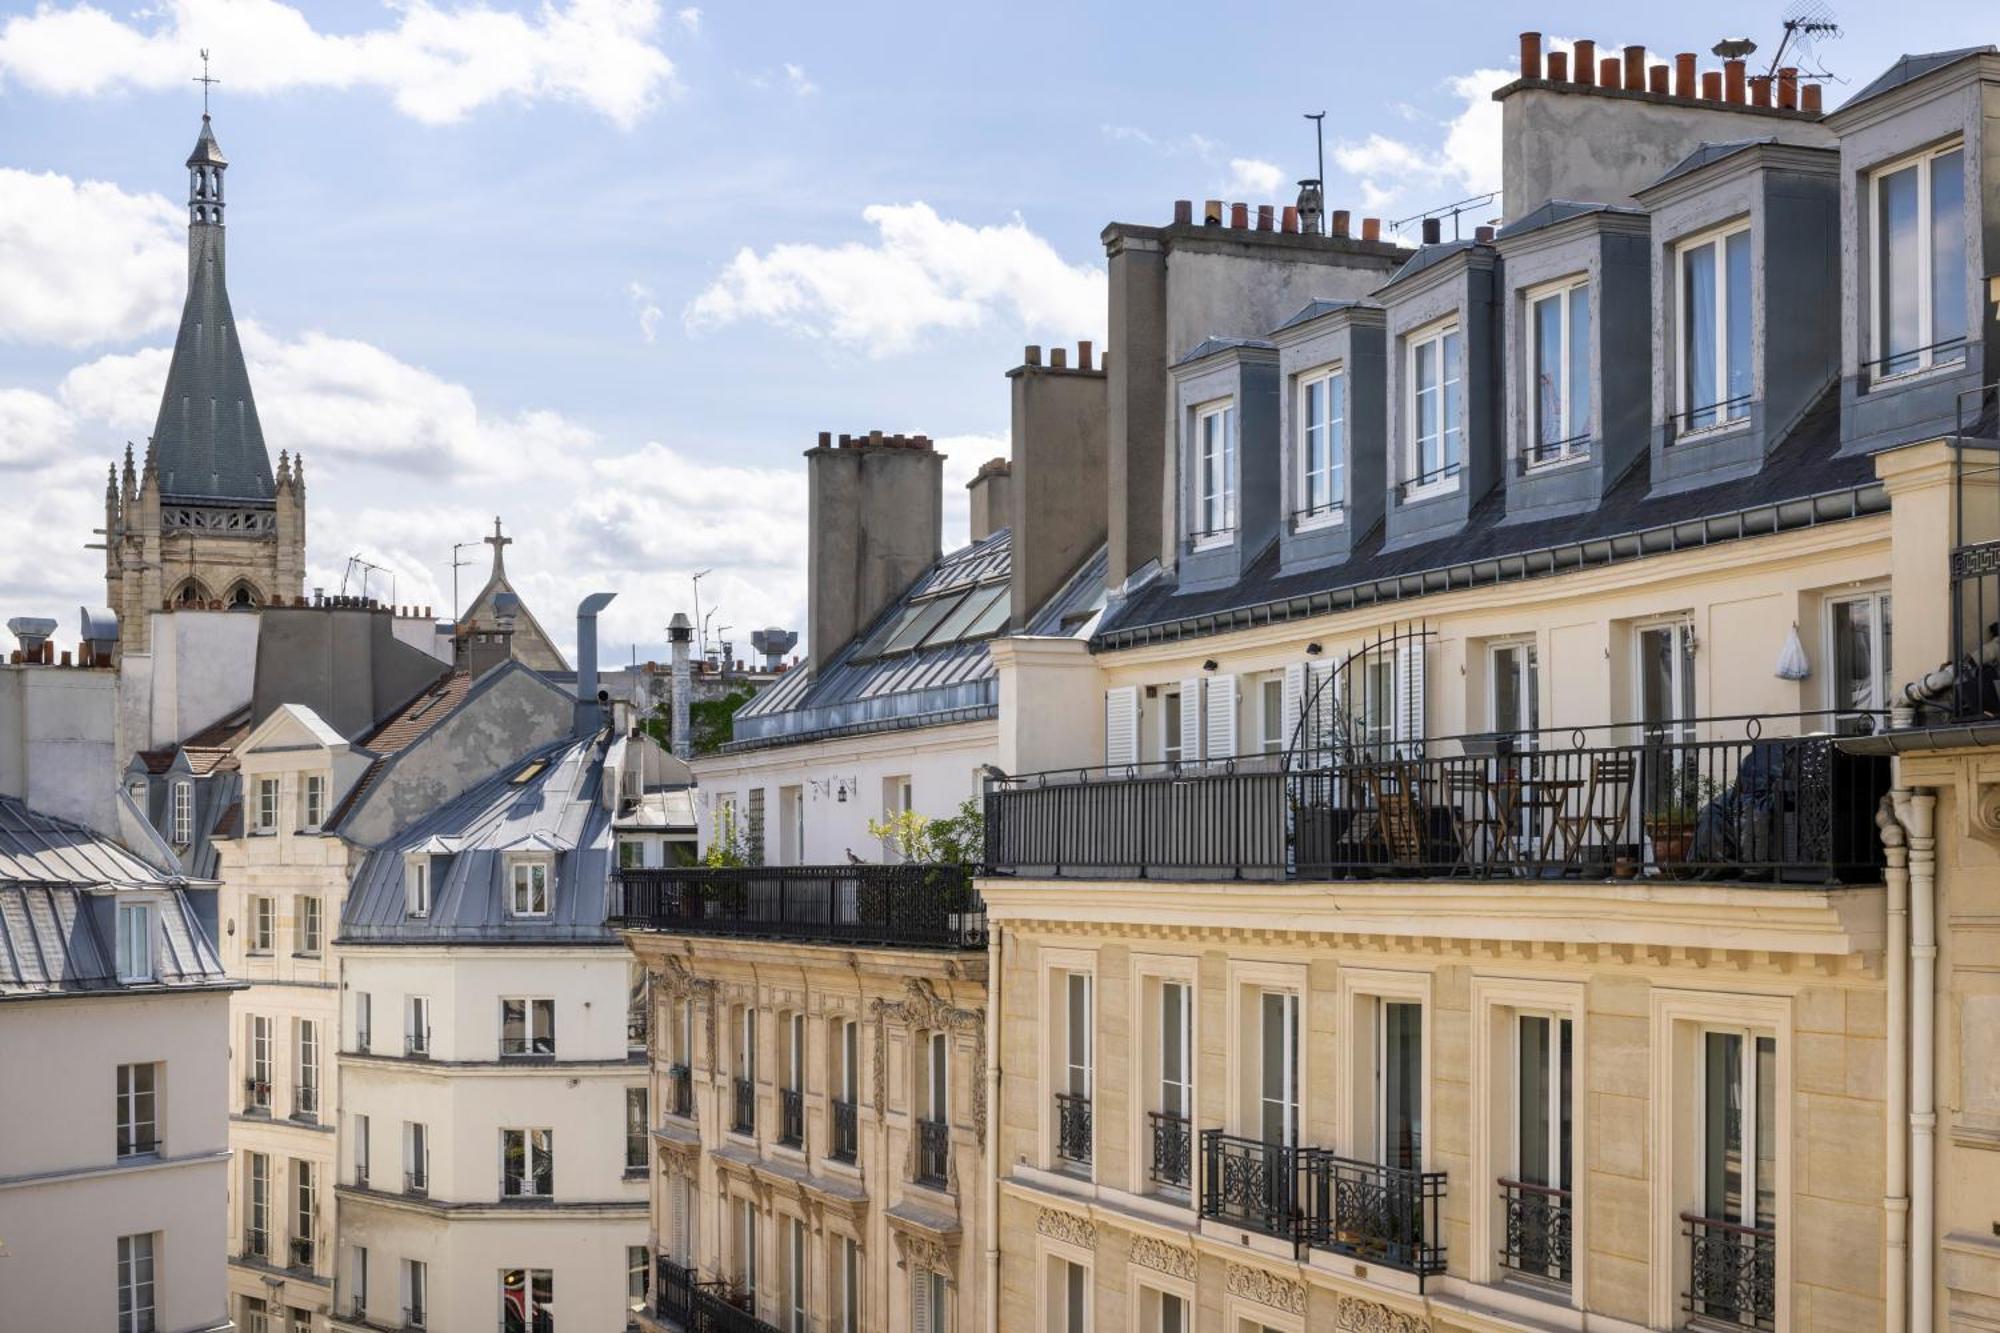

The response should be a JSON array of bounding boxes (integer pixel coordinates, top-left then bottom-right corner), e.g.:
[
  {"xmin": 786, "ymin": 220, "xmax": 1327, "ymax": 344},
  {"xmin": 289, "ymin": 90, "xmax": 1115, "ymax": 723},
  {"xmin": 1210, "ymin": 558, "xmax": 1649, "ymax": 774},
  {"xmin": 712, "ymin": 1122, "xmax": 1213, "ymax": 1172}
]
[{"xmin": 982, "ymin": 879, "xmax": 1886, "ymax": 1333}]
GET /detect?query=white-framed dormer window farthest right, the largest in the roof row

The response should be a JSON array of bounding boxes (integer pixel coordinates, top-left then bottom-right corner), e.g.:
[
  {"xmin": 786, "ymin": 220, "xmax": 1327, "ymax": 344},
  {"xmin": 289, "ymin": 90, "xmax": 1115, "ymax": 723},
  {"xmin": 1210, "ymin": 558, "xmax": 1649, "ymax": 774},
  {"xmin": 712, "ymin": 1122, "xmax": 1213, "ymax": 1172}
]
[{"xmin": 1868, "ymin": 144, "xmax": 1966, "ymax": 378}]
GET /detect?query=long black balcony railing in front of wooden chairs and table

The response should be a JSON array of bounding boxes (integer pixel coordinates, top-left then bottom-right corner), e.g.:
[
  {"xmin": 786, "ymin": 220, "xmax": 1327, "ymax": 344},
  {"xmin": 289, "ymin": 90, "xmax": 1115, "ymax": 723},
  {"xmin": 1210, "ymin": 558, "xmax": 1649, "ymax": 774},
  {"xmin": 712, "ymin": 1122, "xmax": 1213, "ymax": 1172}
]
[{"xmin": 986, "ymin": 711, "xmax": 1890, "ymax": 883}]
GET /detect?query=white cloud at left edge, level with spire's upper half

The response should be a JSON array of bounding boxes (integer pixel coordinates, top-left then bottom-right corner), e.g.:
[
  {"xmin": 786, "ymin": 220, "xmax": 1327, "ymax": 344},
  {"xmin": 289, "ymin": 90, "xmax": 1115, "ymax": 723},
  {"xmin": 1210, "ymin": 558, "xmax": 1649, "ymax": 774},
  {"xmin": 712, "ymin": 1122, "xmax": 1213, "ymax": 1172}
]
[{"xmin": 0, "ymin": 166, "xmax": 188, "ymax": 346}]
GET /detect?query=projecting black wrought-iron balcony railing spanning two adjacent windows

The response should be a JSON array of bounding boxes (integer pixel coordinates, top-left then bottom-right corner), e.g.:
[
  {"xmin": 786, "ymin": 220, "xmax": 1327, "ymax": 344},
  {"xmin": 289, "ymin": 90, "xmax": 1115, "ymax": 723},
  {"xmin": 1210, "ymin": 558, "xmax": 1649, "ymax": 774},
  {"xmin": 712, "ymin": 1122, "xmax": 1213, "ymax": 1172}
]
[{"xmin": 1200, "ymin": 1129, "xmax": 1444, "ymax": 1277}]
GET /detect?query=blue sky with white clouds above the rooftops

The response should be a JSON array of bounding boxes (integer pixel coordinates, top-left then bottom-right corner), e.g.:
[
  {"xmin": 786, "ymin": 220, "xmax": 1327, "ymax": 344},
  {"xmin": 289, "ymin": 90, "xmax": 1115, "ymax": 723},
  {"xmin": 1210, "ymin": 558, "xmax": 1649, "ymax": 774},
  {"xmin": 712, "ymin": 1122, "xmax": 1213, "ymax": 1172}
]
[{"xmin": 0, "ymin": 0, "xmax": 1996, "ymax": 656}]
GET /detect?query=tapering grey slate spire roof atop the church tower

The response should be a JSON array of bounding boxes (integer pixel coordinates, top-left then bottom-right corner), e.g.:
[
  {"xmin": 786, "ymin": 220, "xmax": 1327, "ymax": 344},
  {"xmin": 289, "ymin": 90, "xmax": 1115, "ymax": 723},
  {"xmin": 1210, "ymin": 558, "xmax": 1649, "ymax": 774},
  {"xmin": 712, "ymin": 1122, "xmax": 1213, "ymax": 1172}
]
[{"xmin": 152, "ymin": 116, "xmax": 274, "ymax": 504}]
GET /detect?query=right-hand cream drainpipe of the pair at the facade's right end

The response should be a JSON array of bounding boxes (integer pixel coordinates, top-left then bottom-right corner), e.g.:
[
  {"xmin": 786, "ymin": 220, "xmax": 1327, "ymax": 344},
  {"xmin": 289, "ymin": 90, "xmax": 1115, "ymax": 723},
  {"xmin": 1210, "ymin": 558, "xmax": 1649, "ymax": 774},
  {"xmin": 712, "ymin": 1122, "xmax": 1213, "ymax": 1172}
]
[{"xmin": 1894, "ymin": 789, "xmax": 1938, "ymax": 1333}]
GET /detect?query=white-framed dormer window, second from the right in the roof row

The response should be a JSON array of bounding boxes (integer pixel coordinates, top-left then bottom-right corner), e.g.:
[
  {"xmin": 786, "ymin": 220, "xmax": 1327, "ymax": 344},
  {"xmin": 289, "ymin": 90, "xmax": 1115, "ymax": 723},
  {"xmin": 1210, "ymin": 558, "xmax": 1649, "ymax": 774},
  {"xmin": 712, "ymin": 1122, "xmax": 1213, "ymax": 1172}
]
[{"xmin": 1676, "ymin": 226, "xmax": 1752, "ymax": 432}]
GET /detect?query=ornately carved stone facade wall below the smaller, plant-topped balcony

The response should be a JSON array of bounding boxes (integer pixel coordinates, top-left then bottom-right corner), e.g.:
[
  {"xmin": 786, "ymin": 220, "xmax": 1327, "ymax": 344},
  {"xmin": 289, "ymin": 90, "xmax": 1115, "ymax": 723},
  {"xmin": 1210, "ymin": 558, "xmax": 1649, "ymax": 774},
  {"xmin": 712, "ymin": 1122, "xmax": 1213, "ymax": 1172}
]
[{"xmin": 626, "ymin": 931, "xmax": 988, "ymax": 1333}]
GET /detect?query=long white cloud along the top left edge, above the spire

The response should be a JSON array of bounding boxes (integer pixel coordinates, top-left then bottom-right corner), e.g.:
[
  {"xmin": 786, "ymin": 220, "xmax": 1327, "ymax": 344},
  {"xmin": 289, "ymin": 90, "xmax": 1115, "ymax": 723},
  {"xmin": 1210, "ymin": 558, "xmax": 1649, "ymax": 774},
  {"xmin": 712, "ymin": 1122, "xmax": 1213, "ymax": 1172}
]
[{"xmin": 0, "ymin": 0, "xmax": 686, "ymax": 126}]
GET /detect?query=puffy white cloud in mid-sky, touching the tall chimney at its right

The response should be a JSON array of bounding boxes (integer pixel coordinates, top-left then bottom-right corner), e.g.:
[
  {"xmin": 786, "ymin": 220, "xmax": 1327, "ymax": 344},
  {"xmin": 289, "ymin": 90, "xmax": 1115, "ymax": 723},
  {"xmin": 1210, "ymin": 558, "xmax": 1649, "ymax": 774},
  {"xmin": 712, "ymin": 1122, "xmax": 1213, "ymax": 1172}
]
[{"xmin": 684, "ymin": 202, "xmax": 1106, "ymax": 356}]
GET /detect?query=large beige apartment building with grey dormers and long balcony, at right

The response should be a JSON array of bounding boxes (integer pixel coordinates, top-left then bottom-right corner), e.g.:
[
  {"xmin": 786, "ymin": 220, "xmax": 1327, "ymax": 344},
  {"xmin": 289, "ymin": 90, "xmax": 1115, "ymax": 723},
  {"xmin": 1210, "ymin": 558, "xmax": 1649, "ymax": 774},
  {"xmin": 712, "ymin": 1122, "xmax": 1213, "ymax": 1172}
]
[{"xmin": 972, "ymin": 34, "xmax": 2000, "ymax": 1333}]
